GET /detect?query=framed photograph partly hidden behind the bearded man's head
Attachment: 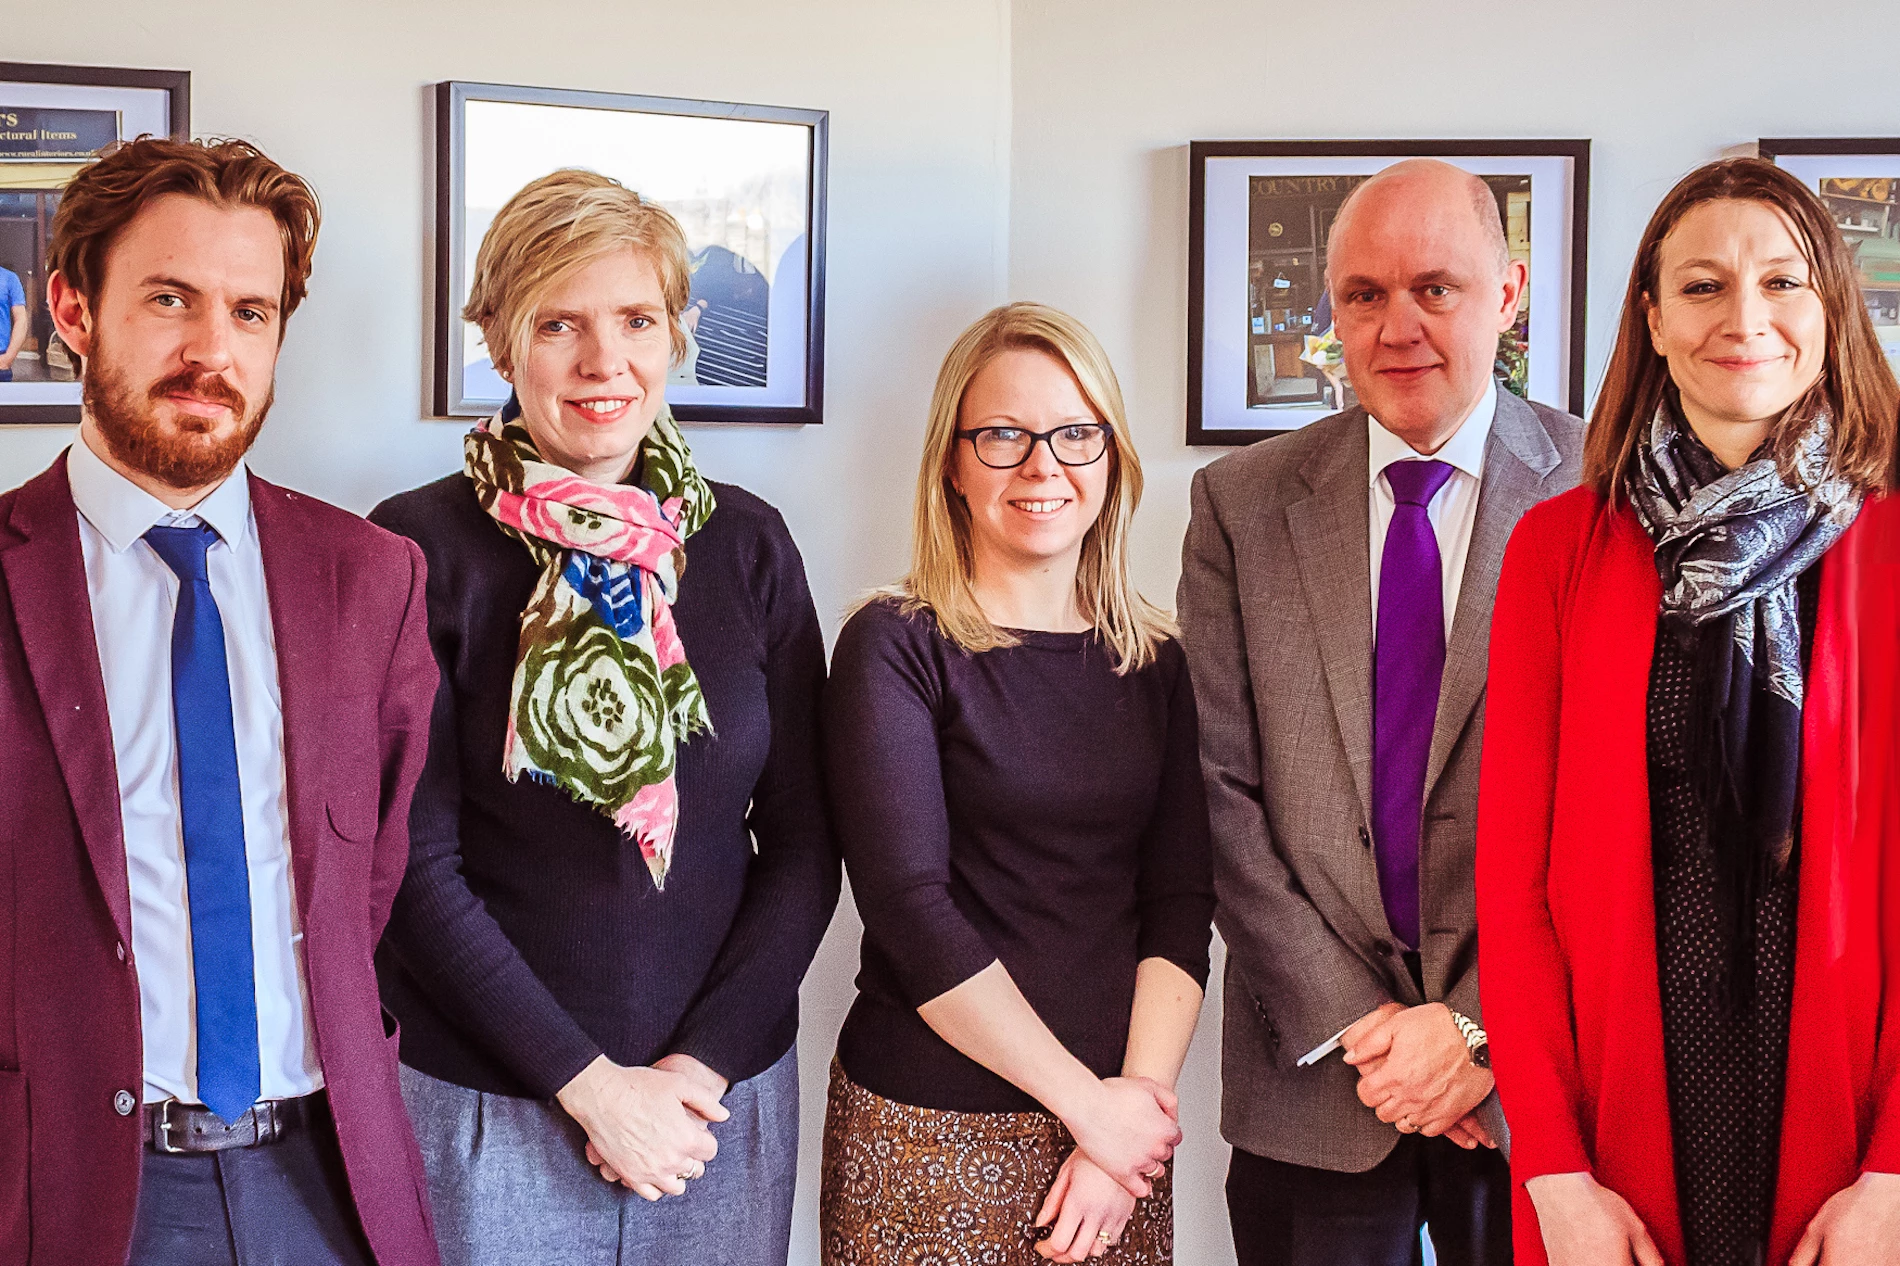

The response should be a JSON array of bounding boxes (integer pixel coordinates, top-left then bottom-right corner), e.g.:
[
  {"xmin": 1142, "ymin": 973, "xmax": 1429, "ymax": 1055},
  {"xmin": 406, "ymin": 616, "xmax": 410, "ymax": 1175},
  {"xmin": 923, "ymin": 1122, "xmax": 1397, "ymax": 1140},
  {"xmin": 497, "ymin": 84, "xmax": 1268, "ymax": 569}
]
[{"xmin": 0, "ymin": 61, "xmax": 192, "ymax": 424}]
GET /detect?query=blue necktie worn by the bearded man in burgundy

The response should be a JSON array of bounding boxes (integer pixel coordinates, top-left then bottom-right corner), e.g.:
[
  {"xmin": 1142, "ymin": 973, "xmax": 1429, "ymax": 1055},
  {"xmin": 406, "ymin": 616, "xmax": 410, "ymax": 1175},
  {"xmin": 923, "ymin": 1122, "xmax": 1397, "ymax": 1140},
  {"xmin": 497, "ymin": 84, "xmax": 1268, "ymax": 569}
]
[{"xmin": 144, "ymin": 525, "xmax": 258, "ymax": 1122}]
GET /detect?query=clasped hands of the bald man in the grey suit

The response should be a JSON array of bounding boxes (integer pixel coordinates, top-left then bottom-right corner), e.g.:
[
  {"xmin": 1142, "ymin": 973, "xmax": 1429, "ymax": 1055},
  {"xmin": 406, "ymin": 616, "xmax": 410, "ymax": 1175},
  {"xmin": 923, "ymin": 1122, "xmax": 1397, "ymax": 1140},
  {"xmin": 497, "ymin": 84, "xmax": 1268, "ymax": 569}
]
[{"xmin": 1345, "ymin": 1002, "xmax": 1493, "ymax": 1137}]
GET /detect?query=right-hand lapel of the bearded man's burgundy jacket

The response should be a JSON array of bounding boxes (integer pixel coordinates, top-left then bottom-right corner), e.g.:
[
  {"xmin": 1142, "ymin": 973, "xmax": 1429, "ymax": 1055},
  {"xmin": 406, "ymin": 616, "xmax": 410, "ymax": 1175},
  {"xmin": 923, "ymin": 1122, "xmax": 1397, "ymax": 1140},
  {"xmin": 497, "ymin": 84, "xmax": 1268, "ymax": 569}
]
[{"xmin": 251, "ymin": 475, "xmax": 336, "ymax": 927}]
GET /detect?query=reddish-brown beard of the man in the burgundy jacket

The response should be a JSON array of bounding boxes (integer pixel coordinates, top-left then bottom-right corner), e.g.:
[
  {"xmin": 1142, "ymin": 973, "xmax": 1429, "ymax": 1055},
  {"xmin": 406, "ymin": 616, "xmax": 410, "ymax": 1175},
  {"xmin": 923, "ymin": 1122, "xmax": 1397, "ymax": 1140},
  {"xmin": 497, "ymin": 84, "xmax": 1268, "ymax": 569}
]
[{"xmin": 82, "ymin": 344, "xmax": 276, "ymax": 490}]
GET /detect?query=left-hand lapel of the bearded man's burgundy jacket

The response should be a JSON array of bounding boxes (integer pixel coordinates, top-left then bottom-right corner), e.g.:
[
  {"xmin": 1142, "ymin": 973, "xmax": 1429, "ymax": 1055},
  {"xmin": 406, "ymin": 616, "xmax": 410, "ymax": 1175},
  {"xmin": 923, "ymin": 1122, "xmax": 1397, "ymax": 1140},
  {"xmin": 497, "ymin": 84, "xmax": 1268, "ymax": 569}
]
[{"xmin": 0, "ymin": 452, "xmax": 131, "ymax": 945}]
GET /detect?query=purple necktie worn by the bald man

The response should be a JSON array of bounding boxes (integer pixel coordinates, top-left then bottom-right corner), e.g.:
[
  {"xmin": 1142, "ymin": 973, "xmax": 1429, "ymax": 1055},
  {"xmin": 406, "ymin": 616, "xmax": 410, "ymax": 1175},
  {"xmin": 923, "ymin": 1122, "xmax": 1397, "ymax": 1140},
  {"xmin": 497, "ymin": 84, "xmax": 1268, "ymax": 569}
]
[{"xmin": 1372, "ymin": 462, "xmax": 1452, "ymax": 949}]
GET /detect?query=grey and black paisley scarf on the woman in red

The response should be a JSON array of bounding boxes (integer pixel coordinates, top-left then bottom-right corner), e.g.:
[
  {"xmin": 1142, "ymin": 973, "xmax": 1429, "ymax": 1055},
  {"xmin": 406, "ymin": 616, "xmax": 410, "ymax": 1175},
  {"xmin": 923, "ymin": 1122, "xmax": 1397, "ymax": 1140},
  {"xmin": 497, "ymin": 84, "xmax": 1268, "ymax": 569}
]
[{"xmin": 1628, "ymin": 392, "xmax": 1862, "ymax": 1011}]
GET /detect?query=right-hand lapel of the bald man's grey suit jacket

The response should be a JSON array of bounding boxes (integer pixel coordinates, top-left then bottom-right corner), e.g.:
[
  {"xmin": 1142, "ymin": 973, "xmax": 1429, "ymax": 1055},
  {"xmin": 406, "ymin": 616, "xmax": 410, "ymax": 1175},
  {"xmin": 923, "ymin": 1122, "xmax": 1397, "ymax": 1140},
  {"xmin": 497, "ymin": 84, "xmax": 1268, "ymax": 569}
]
[{"xmin": 1425, "ymin": 388, "xmax": 1560, "ymax": 798}]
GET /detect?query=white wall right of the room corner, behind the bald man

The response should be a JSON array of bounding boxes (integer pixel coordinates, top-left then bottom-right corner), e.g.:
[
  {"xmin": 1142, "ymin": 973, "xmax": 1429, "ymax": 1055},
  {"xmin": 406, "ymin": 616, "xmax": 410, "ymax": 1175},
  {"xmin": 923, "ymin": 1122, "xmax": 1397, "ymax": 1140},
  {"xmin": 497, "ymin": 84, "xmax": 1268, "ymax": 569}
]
[{"xmin": 1009, "ymin": 0, "xmax": 1900, "ymax": 1266}]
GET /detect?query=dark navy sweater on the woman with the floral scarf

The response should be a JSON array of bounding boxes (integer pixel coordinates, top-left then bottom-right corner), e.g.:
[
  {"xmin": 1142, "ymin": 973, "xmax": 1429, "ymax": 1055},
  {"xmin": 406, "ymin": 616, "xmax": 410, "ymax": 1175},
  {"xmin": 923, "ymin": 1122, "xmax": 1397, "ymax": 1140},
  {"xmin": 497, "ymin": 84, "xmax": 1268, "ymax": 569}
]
[{"xmin": 371, "ymin": 475, "xmax": 840, "ymax": 1099}]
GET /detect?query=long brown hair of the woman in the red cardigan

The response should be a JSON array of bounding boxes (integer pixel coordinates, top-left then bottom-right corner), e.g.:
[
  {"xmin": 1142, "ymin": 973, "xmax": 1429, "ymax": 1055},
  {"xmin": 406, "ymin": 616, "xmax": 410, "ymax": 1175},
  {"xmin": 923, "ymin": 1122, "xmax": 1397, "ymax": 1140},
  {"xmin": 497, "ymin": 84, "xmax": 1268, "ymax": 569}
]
[{"xmin": 1583, "ymin": 158, "xmax": 1900, "ymax": 500}]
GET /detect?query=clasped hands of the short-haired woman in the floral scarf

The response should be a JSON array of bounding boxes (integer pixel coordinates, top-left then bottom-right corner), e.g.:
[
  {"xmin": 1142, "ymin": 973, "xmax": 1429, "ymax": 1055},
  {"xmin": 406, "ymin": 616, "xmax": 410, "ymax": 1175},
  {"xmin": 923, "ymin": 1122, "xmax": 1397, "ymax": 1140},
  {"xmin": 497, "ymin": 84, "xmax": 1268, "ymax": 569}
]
[{"xmin": 557, "ymin": 1055, "xmax": 732, "ymax": 1199}]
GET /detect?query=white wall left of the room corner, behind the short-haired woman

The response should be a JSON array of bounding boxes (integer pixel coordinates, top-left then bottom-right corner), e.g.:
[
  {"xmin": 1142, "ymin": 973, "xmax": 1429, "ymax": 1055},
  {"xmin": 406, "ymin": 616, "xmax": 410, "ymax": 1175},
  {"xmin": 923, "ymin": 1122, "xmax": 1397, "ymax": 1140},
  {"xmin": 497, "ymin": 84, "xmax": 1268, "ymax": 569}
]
[{"xmin": 0, "ymin": 0, "xmax": 1009, "ymax": 1262}]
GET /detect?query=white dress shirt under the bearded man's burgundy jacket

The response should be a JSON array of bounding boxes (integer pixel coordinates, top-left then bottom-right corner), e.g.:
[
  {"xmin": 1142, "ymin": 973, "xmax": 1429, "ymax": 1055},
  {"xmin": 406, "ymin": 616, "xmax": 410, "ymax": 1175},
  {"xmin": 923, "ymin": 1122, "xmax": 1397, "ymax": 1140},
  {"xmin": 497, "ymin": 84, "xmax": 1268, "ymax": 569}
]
[{"xmin": 67, "ymin": 439, "xmax": 323, "ymax": 1103}]
